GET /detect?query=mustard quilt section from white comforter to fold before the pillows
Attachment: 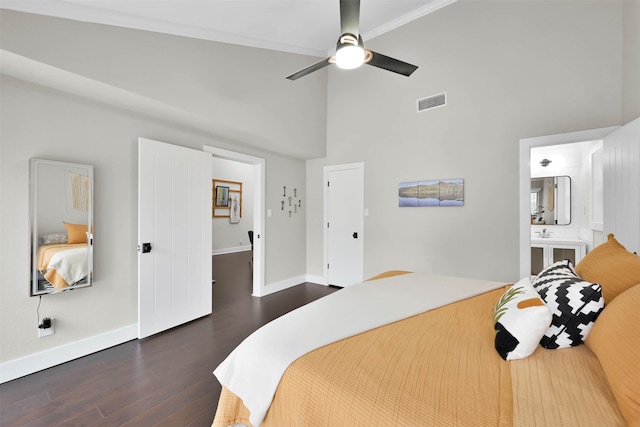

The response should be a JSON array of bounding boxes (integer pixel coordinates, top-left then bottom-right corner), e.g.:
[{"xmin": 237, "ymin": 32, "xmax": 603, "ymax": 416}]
[{"xmin": 213, "ymin": 288, "xmax": 513, "ymax": 427}]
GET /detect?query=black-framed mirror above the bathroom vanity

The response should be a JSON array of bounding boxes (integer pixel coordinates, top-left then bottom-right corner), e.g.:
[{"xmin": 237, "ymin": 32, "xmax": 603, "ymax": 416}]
[{"xmin": 531, "ymin": 176, "xmax": 571, "ymax": 225}]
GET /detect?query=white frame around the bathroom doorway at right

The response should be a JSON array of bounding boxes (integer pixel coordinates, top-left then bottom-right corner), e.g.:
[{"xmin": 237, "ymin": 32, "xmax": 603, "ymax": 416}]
[{"xmin": 518, "ymin": 126, "xmax": 620, "ymax": 277}]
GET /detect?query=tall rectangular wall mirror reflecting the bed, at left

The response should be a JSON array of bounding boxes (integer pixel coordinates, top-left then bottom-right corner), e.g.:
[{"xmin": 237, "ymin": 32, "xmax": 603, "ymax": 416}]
[{"xmin": 29, "ymin": 159, "xmax": 93, "ymax": 296}]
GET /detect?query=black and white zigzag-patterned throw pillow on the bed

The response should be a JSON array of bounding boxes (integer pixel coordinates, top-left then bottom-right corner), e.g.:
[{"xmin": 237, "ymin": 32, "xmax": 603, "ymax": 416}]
[{"xmin": 533, "ymin": 259, "xmax": 604, "ymax": 349}]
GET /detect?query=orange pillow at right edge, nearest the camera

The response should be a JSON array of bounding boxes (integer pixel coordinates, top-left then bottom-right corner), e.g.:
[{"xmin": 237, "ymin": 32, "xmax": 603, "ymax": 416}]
[{"xmin": 585, "ymin": 283, "xmax": 640, "ymax": 426}]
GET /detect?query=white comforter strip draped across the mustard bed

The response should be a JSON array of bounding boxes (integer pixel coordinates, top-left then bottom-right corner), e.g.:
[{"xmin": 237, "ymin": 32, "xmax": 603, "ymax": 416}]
[{"xmin": 214, "ymin": 273, "xmax": 505, "ymax": 426}]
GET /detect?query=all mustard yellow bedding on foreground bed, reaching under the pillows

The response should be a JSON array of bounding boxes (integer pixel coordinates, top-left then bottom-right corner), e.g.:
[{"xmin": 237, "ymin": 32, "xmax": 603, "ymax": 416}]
[{"xmin": 213, "ymin": 280, "xmax": 625, "ymax": 427}]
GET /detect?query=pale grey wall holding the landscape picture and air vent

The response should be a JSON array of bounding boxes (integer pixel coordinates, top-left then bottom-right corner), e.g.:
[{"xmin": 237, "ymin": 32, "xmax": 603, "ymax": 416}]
[{"xmin": 307, "ymin": 1, "xmax": 637, "ymax": 281}]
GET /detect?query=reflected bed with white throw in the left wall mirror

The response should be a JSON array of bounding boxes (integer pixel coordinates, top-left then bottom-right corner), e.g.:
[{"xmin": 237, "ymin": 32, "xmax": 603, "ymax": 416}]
[{"xmin": 37, "ymin": 242, "xmax": 89, "ymax": 290}]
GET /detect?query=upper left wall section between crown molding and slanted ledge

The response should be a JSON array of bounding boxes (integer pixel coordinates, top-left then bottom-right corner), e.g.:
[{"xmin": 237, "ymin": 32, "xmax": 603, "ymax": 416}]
[{"xmin": 0, "ymin": 9, "xmax": 326, "ymax": 158}]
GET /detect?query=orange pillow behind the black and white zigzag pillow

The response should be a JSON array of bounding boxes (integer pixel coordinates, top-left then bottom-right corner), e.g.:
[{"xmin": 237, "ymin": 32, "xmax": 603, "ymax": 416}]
[{"xmin": 575, "ymin": 234, "xmax": 640, "ymax": 304}]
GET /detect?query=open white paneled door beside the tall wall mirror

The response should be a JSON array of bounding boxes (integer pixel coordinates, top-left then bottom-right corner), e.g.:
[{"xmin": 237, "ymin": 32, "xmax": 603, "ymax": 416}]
[{"xmin": 138, "ymin": 138, "xmax": 212, "ymax": 338}]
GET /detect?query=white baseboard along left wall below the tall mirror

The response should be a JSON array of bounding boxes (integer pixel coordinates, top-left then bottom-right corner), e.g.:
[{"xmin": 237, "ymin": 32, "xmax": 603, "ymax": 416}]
[{"xmin": 0, "ymin": 323, "xmax": 138, "ymax": 384}]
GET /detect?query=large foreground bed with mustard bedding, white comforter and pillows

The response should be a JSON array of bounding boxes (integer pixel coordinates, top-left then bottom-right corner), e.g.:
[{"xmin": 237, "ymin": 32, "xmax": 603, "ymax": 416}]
[{"xmin": 213, "ymin": 235, "xmax": 640, "ymax": 427}]
